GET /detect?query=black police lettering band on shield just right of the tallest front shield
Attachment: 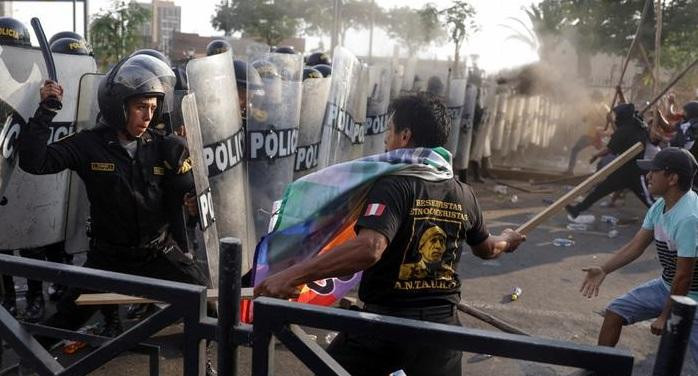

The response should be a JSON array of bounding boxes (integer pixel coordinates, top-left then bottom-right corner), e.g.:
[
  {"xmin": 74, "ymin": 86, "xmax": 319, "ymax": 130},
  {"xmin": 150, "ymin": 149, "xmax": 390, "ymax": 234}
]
[{"xmin": 247, "ymin": 128, "xmax": 298, "ymax": 161}]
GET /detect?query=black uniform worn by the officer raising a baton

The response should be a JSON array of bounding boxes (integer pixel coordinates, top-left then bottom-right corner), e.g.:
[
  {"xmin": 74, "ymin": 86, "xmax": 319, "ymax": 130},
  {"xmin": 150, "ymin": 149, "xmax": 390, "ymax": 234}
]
[{"xmin": 18, "ymin": 57, "xmax": 207, "ymax": 329}]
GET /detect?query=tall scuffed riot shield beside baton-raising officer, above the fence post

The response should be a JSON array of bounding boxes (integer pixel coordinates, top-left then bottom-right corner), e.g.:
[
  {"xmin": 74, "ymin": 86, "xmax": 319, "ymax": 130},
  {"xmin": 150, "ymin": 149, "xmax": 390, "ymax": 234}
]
[{"xmin": 187, "ymin": 51, "xmax": 256, "ymax": 273}]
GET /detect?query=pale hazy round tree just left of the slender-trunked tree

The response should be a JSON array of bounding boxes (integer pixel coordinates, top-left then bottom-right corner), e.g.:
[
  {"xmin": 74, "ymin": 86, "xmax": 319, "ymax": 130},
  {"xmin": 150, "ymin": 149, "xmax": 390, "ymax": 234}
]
[{"xmin": 386, "ymin": 7, "xmax": 446, "ymax": 55}]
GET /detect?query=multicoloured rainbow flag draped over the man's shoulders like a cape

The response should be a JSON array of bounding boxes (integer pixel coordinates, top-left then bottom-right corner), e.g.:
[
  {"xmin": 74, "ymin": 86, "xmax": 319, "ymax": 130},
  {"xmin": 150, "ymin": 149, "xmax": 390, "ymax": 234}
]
[{"xmin": 253, "ymin": 147, "xmax": 453, "ymax": 314}]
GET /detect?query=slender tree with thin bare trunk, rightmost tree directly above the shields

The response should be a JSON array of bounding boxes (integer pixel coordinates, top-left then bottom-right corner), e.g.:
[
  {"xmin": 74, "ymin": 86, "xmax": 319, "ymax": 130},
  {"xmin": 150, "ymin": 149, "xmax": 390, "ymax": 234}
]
[{"xmin": 422, "ymin": 0, "xmax": 479, "ymax": 75}]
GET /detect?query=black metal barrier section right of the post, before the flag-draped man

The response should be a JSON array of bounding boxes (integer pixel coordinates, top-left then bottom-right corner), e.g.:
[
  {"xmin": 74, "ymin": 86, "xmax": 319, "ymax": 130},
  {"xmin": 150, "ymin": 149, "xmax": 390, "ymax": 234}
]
[{"xmin": 252, "ymin": 297, "xmax": 633, "ymax": 376}]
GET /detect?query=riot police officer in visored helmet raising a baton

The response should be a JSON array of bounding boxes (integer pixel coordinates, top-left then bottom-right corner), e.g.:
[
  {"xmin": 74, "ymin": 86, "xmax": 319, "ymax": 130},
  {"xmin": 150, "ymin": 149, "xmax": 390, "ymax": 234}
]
[{"xmin": 18, "ymin": 54, "xmax": 207, "ymax": 335}]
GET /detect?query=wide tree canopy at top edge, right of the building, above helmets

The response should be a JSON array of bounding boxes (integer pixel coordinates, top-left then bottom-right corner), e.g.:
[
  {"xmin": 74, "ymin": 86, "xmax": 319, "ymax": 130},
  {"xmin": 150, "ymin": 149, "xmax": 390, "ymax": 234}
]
[{"xmin": 211, "ymin": 0, "xmax": 301, "ymax": 46}]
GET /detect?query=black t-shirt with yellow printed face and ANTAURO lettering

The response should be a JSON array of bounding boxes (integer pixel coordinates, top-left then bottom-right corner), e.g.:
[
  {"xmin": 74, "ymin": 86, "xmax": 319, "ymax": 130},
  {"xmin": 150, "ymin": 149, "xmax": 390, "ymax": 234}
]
[{"xmin": 356, "ymin": 176, "xmax": 489, "ymax": 307}]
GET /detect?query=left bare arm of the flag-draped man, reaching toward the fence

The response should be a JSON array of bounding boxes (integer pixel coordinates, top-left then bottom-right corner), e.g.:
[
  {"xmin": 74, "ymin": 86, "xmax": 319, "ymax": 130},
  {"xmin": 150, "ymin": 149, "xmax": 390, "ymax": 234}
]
[{"xmin": 254, "ymin": 228, "xmax": 388, "ymax": 299}]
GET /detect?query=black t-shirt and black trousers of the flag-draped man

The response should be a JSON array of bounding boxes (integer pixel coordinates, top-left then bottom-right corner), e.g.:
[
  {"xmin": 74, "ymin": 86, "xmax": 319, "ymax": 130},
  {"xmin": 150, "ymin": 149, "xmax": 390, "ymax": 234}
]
[{"xmin": 328, "ymin": 176, "xmax": 489, "ymax": 375}]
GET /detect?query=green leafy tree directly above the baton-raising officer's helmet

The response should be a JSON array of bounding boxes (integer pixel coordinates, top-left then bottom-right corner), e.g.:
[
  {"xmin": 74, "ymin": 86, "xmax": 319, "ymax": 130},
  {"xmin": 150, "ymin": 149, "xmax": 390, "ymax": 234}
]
[{"xmin": 90, "ymin": 0, "xmax": 150, "ymax": 68}]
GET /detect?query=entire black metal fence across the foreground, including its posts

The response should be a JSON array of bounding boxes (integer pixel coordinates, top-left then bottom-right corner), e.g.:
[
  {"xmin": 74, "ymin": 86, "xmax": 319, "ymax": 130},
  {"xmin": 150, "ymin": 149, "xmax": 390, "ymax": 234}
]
[{"xmin": 0, "ymin": 238, "xmax": 695, "ymax": 376}]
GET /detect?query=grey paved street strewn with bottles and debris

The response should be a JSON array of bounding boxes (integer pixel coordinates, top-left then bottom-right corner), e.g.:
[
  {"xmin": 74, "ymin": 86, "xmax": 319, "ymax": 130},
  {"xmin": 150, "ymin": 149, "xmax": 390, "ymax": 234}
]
[{"xmin": 5, "ymin": 178, "xmax": 695, "ymax": 376}]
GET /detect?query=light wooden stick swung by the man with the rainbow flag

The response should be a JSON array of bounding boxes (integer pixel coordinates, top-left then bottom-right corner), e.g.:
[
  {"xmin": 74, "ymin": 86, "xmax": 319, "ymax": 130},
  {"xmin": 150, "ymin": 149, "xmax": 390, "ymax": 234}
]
[{"xmin": 516, "ymin": 142, "xmax": 644, "ymax": 234}]
